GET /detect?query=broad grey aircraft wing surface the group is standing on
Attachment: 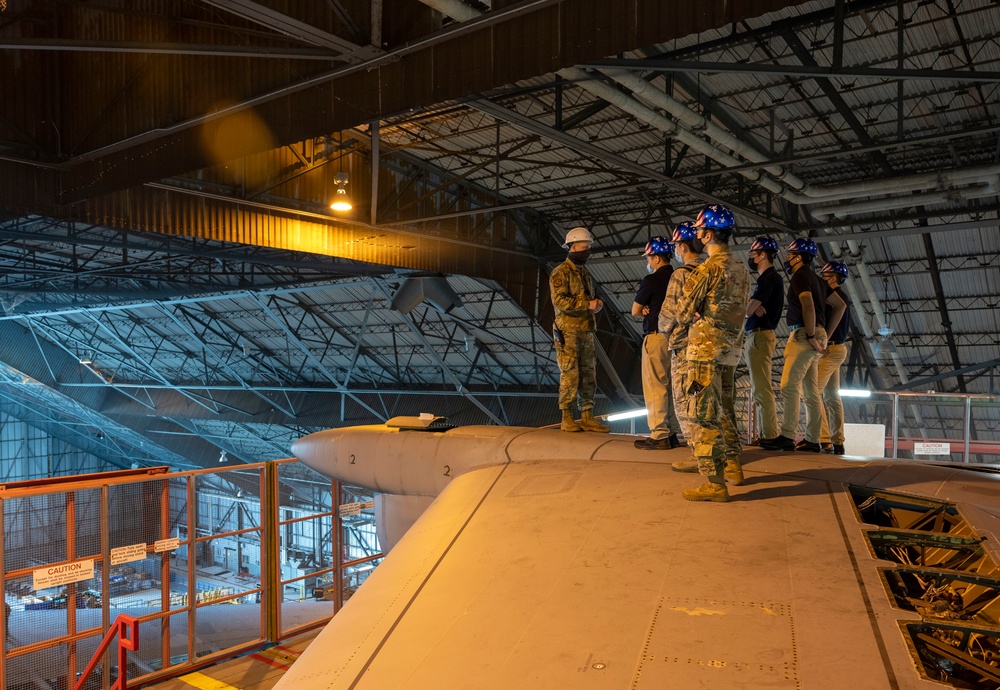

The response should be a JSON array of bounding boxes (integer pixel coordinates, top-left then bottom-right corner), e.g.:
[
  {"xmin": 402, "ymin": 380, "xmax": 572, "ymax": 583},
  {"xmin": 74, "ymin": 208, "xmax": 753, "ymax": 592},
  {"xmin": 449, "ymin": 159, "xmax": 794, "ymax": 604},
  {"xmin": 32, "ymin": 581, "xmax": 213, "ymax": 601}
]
[{"xmin": 278, "ymin": 432, "xmax": 1000, "ymax": 690}]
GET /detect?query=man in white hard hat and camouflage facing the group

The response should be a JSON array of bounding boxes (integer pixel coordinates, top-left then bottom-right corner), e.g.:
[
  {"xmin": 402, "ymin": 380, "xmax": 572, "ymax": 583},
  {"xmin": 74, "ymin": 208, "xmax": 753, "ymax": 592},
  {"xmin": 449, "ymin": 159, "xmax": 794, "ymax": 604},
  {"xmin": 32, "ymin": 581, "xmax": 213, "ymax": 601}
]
[{"xmin": 549, "ymin": 228, "xmax": 611, "ymax": 433}]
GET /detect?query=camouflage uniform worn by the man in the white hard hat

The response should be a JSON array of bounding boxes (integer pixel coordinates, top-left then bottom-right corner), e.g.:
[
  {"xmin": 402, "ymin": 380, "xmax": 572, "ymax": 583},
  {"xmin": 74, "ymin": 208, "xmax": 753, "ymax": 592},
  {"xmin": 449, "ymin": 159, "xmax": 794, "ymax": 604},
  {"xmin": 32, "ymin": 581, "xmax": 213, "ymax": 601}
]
[{"xmin": 549, "ymin": 259, "xmax": 597, "ymax": 410}]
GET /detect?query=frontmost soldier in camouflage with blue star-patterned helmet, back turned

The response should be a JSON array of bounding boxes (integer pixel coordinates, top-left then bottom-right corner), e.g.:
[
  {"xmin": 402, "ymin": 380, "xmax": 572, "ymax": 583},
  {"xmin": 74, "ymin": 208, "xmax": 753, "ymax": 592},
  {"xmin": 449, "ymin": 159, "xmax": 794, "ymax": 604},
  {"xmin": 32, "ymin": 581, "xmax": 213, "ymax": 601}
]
[{"xmin": 677, "ymin": 204, "xmax": 750, "ymax": 502}]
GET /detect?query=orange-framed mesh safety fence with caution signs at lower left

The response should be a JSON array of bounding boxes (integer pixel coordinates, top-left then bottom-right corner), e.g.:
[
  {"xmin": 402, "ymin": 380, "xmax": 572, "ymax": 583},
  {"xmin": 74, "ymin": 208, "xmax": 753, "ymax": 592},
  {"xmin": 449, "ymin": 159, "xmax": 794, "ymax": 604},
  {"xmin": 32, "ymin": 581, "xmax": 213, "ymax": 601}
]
[{"xmin": 0, "ymin": 460, "xmax": 381, "ymax": 690}]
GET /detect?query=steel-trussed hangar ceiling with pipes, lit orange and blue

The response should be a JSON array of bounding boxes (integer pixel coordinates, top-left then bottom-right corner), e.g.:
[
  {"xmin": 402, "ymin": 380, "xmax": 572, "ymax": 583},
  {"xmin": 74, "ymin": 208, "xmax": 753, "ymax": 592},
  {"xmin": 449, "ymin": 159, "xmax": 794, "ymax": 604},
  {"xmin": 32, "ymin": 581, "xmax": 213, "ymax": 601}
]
[{"xmin": 0, "ymin": 0, "xmax": 1000, "ymax": 464}]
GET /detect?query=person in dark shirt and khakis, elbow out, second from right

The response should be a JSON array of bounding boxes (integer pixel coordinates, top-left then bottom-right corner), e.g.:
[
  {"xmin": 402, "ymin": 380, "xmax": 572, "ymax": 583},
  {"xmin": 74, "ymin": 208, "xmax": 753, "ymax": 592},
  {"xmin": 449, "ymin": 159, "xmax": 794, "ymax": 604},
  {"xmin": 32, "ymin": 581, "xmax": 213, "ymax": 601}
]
[{"xmin": 760, "ymin": 237, "xmax": 847, "ymax": 453}]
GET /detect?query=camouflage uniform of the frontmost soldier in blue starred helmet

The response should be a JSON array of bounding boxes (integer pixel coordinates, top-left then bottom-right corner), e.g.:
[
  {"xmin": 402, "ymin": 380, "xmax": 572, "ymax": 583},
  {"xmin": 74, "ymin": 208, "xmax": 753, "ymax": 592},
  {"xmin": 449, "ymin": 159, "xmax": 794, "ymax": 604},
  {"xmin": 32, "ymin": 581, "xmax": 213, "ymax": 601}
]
[{"xmin": 677, "ymin": 245, "xmax": 750, "ymax": 483}]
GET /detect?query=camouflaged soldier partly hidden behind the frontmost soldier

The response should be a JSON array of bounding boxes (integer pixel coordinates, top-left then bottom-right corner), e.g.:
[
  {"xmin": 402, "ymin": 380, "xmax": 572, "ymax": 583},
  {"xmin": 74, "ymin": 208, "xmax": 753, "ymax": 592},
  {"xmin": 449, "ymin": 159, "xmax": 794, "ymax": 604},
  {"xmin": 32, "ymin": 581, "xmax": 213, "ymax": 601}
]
[{"xmin": 657, "ymin": 220, "xmax": 700, "ymax": 472}]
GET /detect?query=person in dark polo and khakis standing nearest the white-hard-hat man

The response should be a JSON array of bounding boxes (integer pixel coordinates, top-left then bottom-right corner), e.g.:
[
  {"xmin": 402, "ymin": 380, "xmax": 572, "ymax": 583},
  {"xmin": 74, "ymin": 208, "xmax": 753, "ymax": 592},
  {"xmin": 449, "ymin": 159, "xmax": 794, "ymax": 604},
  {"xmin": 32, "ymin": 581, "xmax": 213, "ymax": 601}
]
[{"xmin": 632, "ymin": 235, "xmax": 680, "ymax": 450}]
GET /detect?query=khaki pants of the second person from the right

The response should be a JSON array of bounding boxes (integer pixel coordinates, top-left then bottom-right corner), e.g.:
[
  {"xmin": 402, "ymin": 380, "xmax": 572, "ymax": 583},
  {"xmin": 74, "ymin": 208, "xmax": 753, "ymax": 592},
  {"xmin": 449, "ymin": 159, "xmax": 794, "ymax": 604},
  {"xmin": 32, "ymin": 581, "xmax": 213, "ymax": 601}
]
[{"xmin": 781, "ymin": 327, "xmax": 826, "ymax": 443}]
